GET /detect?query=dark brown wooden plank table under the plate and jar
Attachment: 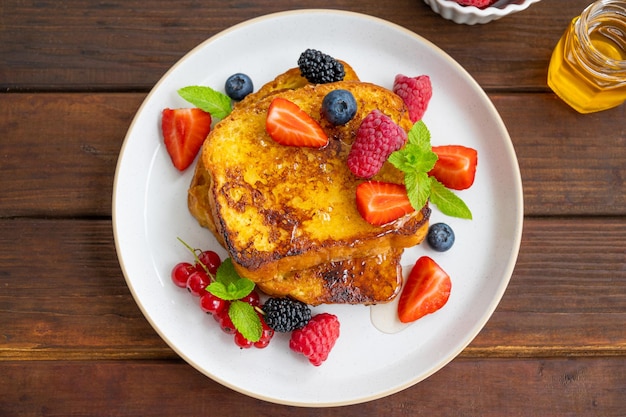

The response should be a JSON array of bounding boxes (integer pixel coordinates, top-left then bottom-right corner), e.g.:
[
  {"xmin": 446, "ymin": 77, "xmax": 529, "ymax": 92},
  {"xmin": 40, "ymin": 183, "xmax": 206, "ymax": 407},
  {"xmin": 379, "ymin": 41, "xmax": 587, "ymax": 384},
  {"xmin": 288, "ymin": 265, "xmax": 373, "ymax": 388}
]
[{"xmin": 0, "ymin": 0, "xmax": 626, "ymax": 417}]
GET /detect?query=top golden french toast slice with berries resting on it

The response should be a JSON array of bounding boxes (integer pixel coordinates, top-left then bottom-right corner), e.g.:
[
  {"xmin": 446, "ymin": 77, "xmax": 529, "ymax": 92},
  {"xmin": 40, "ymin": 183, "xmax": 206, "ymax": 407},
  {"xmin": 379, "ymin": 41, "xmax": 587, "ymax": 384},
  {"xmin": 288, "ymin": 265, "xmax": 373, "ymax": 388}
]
[{"xmin": 189, "ymin": 81, "xmax": 429, "ymax": 286}]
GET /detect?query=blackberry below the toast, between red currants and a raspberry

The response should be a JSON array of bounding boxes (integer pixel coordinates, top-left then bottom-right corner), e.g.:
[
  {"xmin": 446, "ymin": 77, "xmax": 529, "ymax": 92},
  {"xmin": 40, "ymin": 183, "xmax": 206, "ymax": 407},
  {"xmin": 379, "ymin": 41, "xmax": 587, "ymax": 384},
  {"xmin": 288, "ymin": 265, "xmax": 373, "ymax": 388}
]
[{"xmin": 263, "ymin": 298, "xmax": 311, "ymax": 333}]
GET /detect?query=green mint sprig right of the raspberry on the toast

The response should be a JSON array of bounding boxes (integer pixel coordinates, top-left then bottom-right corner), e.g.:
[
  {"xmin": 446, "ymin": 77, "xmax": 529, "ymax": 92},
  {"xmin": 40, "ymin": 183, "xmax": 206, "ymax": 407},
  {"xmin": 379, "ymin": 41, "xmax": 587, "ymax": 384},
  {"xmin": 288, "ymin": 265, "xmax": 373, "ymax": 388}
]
[{"xmin": 389, "ymin": 120, "xmax": 472, "ymax": 219}]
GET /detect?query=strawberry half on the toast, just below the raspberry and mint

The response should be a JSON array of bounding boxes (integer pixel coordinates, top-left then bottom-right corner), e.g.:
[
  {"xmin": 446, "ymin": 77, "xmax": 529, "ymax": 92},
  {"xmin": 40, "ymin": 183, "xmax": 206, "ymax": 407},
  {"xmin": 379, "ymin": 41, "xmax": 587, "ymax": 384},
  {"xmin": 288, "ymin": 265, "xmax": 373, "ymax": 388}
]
[{"xmin": 356, "ymin": 181, "xmax": 415, "ymax": 226}]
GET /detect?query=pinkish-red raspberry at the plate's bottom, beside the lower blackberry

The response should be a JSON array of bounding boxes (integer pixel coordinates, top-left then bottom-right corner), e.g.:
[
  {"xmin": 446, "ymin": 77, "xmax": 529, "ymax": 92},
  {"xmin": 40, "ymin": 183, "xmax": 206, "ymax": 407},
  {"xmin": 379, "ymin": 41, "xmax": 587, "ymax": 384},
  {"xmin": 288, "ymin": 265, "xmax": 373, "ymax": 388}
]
[{"xmin": 289, "ymin": 313, "xmax": 339, "ymax": 366}]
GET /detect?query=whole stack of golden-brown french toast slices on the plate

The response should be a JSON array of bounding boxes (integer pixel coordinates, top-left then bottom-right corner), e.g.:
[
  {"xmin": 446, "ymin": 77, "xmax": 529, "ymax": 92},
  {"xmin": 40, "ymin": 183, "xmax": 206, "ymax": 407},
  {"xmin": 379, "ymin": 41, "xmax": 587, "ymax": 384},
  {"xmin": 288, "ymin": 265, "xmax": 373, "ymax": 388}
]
[{"xmin": 188, "ymin": 62, "xmax": 430, "ymax": 305}]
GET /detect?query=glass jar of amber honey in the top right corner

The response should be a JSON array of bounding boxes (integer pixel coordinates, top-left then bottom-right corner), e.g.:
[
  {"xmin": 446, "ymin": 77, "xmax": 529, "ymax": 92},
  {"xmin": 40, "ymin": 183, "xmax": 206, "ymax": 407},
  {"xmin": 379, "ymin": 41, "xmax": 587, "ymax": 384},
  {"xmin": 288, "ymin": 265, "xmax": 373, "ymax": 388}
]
[{"xmin": 548, "ymin": 0, "xmax": 626, "ymax": 113}]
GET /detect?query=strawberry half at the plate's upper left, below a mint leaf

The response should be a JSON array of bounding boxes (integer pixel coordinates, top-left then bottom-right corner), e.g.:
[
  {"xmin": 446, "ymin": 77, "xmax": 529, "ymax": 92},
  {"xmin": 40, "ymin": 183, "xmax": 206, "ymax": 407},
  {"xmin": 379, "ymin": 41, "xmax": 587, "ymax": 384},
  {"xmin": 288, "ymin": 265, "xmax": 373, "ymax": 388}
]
[{"xmin": 161, "ymin": 108, "xmax": 211, "ymax": 171}]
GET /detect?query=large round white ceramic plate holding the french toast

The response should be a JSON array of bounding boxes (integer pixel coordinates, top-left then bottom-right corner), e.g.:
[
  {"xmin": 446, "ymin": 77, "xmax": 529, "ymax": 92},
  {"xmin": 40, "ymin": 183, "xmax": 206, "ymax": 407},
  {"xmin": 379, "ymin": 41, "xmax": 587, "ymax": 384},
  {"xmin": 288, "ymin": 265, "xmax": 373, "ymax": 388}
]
[{"xmin": 113, "ymin": 10, "xmax": 523, "ymax": 407}]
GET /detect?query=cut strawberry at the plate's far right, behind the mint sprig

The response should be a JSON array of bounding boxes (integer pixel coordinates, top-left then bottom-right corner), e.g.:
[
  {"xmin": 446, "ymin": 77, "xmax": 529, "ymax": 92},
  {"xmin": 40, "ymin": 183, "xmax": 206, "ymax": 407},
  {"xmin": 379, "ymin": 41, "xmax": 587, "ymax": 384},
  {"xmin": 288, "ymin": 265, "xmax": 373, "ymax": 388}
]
[{"xmin": 429, "ymin": 145, "xmax": 478, "ymax": 190}]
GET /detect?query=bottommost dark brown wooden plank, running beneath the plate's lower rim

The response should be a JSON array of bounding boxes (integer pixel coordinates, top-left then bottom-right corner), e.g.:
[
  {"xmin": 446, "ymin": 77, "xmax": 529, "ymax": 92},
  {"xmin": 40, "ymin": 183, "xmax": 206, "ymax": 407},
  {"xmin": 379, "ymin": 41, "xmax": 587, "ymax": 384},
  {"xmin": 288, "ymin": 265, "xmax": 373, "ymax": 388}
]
[{"xmin": 0, "ymin": 357, "xmax": 626, "ymax": 417}]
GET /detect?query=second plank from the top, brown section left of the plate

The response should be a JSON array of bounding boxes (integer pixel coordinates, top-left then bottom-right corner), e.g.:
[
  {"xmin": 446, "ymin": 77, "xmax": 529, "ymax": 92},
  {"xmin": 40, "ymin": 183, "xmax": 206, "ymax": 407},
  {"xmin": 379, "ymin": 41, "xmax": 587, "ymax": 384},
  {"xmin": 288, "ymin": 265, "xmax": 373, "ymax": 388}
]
[{"xmin": 0, "ymin": 93, "xmax": 145, "ymax": 217}]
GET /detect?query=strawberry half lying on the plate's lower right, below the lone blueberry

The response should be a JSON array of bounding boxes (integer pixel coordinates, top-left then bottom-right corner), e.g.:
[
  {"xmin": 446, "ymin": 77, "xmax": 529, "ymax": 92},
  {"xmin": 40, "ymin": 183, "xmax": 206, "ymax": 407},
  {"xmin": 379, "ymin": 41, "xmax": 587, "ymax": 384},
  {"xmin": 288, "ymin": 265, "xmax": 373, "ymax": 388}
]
[{"xmin": 398, "ymin": 256, "xmax": 452, "ymax": 323}]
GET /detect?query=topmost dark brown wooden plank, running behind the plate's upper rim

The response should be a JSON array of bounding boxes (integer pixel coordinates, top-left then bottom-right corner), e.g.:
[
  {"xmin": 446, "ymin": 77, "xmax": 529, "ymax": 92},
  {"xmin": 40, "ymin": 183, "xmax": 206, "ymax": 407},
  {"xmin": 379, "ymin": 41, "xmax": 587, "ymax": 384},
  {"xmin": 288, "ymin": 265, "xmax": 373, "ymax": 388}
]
[{"xmin": 0, "ymin": 0, "xmax": 588, "ymax": 91}]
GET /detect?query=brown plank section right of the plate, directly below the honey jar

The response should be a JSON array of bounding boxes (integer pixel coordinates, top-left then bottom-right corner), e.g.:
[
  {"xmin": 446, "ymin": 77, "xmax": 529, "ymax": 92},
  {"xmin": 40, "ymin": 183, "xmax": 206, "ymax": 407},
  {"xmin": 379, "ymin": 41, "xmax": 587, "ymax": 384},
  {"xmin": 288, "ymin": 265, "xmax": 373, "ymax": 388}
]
[{"xmin": 490, "ymin": 94, "xmax": 626, "ymax": 216}]
